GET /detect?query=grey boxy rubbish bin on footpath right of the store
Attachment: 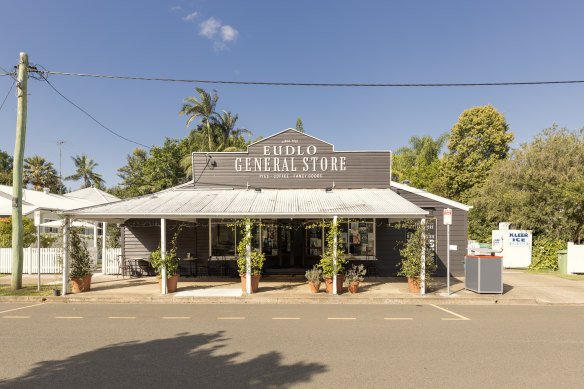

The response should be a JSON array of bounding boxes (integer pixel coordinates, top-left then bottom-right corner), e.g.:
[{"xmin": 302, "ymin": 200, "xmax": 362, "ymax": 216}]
[{"xmin": 464, "ymin": 255, "xmax": 503, "ymax": 293}]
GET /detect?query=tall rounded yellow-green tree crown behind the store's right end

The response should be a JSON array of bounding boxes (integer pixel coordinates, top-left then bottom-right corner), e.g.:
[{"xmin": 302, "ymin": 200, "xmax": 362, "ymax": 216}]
[{"xmin": 436, "ymin": 105, "xmax": 514, "ymax": 203}]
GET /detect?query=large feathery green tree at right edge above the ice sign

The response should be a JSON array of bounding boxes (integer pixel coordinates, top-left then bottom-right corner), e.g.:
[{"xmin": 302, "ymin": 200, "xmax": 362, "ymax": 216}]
[{"xmin": 472, "ymin": 126, "xmax": 584, "ymax": 243}]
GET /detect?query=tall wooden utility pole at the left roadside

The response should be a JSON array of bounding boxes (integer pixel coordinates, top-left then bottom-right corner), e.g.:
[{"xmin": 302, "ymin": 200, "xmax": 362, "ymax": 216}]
[{"xmin": 11, "ymin": 53, "xmax": 28, "ymax": 290}]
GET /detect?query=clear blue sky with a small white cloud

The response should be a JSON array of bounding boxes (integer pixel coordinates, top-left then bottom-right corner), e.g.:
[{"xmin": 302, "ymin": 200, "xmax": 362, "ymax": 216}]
[{"xmin": 0, "ymin": 0, "xmax": 584, "ymax": 188}]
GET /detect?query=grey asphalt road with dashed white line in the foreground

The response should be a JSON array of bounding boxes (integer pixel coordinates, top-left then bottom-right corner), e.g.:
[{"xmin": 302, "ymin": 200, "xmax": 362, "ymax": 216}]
[{"xmin": 0, "ymin": 304, "xmax": 584, "ymax": 388}]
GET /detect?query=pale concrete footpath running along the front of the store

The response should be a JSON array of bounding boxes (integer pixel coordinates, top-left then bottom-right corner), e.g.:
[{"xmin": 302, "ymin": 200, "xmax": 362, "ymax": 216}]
[{"xmin": 0, "ymin": 270, "xmax": 584, "ymax": 305}]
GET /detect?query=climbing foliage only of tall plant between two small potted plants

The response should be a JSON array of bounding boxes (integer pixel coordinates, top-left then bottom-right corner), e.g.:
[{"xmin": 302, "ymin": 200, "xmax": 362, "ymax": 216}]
[{"xmin": 305, "ymin": 219, "xmax": 349, "ymax": 277}]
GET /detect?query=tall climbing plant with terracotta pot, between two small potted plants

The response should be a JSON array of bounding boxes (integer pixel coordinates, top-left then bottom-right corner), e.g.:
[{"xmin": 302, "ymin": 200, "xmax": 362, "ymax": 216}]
[{"xmin": 306, "ymin": 219, "xmax": 349, "ymax": 294}]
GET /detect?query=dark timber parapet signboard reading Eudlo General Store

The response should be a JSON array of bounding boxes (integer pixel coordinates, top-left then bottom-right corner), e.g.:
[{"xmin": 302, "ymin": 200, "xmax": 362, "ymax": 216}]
[{"xmin": 193, "ymin": 129, "xmax": 391, "ymax": 189}]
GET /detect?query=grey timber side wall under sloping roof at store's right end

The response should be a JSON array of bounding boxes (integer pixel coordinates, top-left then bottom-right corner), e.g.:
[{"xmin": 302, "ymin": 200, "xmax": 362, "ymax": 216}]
[{"xmin": 392, "ymin": 188, "xmax": 468, "ymax": 276}]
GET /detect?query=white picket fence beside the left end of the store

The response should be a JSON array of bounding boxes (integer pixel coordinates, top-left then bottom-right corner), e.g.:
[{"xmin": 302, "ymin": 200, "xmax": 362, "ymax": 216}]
[{"xmin": 0, "ymin": 247, "xmax": 122, "ymax": 274}]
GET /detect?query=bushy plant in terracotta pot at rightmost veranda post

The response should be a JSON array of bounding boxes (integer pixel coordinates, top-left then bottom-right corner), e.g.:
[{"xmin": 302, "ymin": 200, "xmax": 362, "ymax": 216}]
[{"xmin": 397, "ymin": 221, "xmax": 438, "ymax": 293}]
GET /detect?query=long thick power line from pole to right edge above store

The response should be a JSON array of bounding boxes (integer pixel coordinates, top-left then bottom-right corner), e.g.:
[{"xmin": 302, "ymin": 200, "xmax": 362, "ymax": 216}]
[{"xmin": 37, "ymin": 70, "xmax": 584, "ymax": 87}]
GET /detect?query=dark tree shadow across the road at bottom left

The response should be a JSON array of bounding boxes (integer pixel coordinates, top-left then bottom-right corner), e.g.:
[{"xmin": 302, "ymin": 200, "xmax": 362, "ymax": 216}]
[{"xmin": 0, "ymin": 332, "xmax": 328, "ymax": 388}]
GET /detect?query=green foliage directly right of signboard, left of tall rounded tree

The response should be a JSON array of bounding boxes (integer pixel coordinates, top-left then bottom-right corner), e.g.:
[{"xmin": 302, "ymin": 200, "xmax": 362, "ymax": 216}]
[{"xmin": 391, "ymin": 134, "xmax": 448, "ymax": 189}]
